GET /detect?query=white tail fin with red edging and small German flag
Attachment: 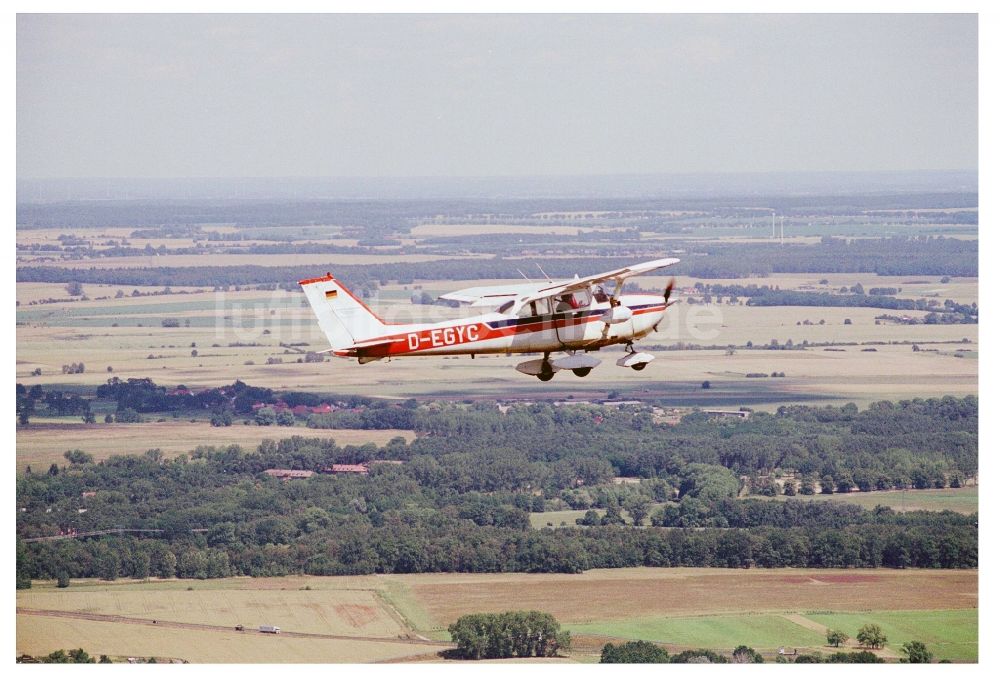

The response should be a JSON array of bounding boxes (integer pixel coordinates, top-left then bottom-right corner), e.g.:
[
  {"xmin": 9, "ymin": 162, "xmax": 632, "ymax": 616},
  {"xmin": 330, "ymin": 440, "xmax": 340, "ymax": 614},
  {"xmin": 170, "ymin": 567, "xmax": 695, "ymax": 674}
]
[{"xmin": 299, "ymin": 274, "xmax": 385, "ymax": 350}]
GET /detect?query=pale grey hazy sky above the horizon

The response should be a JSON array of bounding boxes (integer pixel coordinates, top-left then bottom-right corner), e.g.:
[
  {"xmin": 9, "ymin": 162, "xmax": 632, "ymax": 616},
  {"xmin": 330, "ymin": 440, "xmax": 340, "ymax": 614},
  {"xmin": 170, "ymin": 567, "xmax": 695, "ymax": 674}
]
[{"xmin": 17, "ymin": 15, "xmax": 978, "ymax": 178}]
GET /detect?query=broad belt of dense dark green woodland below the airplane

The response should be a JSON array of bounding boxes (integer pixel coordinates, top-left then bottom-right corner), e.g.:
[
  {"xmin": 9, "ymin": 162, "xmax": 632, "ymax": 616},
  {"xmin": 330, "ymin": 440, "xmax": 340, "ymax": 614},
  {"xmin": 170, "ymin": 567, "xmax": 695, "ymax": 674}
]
[{"xmin": 17, "ymin": 396, "xmax": 978, "ymax": 584}]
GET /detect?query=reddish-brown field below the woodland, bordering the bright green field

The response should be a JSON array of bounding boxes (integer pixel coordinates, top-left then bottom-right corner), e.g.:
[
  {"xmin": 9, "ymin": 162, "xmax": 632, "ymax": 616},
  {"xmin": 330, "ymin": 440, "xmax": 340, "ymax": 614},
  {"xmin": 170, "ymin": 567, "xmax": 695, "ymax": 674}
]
[{"xmin": 398, "ymin": 568, "xmax": 979, "ymax": 627}]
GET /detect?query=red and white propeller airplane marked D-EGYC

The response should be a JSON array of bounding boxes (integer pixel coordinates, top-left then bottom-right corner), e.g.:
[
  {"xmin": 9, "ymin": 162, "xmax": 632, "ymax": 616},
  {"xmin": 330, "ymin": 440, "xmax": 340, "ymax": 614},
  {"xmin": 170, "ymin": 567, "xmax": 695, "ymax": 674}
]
[{"xmin": 299, "ymin": 258, "xmax": 680, "ymax": 382}]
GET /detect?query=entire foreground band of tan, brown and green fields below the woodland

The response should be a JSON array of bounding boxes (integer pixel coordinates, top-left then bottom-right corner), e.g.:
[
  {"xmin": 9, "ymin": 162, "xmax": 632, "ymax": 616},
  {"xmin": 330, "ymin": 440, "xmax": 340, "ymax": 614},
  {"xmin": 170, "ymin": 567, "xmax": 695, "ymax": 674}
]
[{"xmin": 17, "ymin": 568, "xmax": 978, "ymax": 662}]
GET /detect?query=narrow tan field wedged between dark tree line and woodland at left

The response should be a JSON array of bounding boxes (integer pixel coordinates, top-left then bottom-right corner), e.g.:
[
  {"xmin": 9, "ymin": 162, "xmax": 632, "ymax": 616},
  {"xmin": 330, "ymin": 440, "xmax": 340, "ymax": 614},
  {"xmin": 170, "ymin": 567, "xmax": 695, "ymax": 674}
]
[{"xmin": 16, "ymin": 420, "xmax": 414, "ymax": 471}]
